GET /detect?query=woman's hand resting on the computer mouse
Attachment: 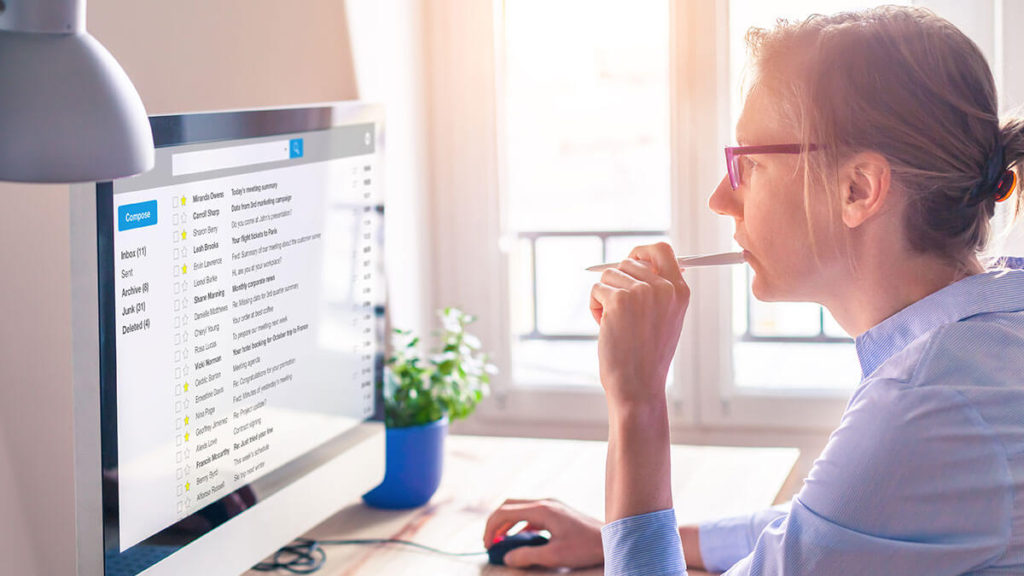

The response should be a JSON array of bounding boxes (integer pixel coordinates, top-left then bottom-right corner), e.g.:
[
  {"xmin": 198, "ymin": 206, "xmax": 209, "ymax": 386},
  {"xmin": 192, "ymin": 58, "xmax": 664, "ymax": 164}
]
[{"xmin": 483, "ymin": 499, "xmax": 604, "ymax": 568}]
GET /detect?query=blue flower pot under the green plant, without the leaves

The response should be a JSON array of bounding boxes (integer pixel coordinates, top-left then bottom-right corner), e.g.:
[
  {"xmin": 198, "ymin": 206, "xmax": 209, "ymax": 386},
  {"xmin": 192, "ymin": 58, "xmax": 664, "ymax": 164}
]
[{"xmin": 362, "ymin": 416, "xmax": 447, "ymax": 509}]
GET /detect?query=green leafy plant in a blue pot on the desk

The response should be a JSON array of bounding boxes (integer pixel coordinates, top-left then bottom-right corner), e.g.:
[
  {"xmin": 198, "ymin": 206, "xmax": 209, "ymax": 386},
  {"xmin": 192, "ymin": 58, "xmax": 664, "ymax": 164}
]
[{"xmin": 362, "ymin": 307, "xmax": 497, "ymax": 508}]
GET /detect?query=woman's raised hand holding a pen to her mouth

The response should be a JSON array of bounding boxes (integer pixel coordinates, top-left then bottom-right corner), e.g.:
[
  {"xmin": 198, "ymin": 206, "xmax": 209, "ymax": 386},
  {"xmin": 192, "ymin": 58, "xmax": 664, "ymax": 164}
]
[{"xmin": 590, "ymin": 242, "xmax": 690, "ymax": 409}]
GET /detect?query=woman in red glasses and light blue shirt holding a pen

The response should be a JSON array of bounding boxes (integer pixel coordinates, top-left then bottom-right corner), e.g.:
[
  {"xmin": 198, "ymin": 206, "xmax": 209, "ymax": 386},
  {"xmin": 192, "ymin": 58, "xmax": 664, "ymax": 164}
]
[{"xmin": 484, "ymin": 7, "xmax": 1024, "ymax": 576}]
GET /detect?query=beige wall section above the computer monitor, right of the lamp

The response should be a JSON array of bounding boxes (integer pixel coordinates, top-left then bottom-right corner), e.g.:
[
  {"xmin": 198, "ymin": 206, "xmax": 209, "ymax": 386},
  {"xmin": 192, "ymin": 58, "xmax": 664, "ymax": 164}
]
[{"xmin": 86, "ymin": 0, "xmax": 357, "ymax": 114}]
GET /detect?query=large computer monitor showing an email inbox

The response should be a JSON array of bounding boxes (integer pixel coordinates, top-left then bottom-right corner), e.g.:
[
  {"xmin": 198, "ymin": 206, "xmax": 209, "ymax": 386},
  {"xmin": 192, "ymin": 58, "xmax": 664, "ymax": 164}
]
[{"xmin": 73, "ymin": 104, "xmax": 385, "ymax": 576}]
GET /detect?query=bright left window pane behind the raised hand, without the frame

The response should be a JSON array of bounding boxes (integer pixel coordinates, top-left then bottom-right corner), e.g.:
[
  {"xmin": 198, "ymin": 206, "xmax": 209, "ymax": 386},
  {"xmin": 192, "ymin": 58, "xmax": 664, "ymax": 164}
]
[{"xmin": 498, "ymin": 0, "xmax": 671, "ymax": 389}]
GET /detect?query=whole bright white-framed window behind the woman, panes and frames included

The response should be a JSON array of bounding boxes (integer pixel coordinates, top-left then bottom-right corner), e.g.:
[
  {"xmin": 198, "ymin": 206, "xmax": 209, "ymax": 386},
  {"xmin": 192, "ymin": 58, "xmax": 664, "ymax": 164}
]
[{"xmin": 427, "ymin": 0, "xmax": 1024, "ymax": 434}]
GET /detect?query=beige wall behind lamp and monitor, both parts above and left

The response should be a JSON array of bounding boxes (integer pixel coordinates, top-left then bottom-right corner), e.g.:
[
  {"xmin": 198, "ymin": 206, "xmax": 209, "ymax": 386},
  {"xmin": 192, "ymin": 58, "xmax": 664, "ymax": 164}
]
[{"xmin": 0, "ymin": 0, "xmax": 357, "ymax": 575}]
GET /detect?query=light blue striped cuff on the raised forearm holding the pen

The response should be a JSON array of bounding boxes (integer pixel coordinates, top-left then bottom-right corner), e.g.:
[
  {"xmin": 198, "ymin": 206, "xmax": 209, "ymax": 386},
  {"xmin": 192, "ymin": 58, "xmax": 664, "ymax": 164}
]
[{"xmin": 601, "ymin": 508, "xmax": 686, "ymax": 576}]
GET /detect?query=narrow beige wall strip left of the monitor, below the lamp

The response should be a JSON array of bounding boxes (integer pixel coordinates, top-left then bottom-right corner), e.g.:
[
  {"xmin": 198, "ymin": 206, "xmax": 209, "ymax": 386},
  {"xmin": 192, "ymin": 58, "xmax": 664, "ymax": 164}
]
[{"xmin": 0, "ymin": 184, "xmax": 75, "ymax": 574}]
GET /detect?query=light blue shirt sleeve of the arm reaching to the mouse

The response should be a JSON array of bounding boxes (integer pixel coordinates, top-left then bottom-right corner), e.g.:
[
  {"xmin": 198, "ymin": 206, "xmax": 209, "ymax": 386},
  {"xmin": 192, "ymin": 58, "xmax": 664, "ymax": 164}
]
[{"xmin": 697, "ymin": 502, "xmax": 790, "ymax": 572}]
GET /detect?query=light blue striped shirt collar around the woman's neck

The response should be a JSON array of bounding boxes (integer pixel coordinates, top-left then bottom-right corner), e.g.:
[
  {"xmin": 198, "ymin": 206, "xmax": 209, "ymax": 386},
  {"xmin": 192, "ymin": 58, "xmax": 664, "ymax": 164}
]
[{"xmin": 856, "ymin": 257, "xmax": 1024, "ymax": 378}]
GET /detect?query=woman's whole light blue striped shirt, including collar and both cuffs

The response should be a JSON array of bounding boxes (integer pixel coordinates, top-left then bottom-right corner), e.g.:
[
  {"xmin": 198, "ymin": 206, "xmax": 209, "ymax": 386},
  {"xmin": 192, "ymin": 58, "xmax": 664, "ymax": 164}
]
[{"xmin": 601, "ymin": 258, "xmax": 1024, "ymax": 576}]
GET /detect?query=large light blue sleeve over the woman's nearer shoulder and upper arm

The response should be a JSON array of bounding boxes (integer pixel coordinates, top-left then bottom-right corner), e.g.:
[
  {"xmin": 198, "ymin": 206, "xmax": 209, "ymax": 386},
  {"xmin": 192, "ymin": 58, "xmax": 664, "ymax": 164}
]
[{"xmin": 726, "ymin": 382, "xmax": 1013, "ymax": 576}]
